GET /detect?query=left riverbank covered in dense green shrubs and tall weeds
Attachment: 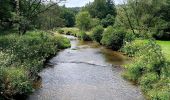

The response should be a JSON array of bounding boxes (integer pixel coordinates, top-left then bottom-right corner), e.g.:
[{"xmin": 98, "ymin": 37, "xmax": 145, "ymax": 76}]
[{"xmin": 0, "ymin": 31, "xmax": 70, "ymax": 100}]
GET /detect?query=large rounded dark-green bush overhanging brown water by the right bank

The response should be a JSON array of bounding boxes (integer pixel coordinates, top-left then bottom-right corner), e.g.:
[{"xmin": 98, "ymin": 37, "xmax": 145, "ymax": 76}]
[{"xmin": 101, "ymin": 26, "xmax": 126, "ymax": 50}]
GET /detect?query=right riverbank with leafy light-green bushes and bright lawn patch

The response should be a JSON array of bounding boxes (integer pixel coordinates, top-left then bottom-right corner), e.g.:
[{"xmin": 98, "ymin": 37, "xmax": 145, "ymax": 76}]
[{"xmin": 122, "ymin": 39, "xmax": 170, "ymax": 100}]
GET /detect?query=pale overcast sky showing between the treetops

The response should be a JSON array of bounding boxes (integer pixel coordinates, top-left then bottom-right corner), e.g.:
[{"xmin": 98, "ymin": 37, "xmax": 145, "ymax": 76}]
[{"xmin": 59, "ymin": 0, "xmax": 121, "ymax": 7}]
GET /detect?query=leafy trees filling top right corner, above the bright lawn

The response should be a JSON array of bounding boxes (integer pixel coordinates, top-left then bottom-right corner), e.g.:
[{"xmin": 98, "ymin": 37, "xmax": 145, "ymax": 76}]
[{"xmin": 116, "ymin": 0, "xmax": 170, "ymax": 40}]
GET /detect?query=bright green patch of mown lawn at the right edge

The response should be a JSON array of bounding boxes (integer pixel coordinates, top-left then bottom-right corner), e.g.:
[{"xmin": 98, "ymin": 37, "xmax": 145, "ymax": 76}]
[{"xmin": 157, "ymin": 41, "xmax": 170, "ymax": 61}]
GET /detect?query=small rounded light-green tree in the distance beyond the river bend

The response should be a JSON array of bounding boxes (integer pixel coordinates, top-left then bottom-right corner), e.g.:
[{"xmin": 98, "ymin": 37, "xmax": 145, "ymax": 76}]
[{"xmin": 76, "ymin": 11, "xmax": 91, "ymax": 30}]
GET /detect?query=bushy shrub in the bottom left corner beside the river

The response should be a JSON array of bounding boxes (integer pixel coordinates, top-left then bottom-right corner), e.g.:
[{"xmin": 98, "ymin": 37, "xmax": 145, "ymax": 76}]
[{"xmin": 0, "ymin": 67, "xmax": 33, "ymax": 98}]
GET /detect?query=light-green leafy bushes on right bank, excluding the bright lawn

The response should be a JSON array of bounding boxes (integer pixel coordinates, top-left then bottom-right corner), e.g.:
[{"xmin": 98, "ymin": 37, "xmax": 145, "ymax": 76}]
[{"xmin": 123, "ymin": 40, "xmax": 170, "ymax": 100}]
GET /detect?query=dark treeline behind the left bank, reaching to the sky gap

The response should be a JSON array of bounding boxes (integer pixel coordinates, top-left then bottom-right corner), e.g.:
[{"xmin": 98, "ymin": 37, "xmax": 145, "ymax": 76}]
[{"xmin": 0, "ymin": 0, "xmax": 78, "ymax": 34}]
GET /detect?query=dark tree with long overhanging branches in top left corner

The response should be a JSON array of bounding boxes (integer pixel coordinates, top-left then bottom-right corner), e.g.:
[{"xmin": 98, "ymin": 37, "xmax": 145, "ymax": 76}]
[{"xmin": 0, "ymin": 0, "xmax": 65, "ymax": 34}]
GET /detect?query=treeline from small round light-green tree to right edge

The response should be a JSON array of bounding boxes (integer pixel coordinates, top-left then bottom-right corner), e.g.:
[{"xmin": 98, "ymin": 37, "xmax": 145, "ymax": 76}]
[{"xmin": 76, "ymin": 0, "xmax": 170, "ymax": 40}]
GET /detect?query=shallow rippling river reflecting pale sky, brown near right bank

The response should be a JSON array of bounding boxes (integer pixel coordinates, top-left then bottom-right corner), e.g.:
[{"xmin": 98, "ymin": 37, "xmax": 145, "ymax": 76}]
[{"xmin": 28, "ymin": 36, "xmax": 144, "ymax": 100}]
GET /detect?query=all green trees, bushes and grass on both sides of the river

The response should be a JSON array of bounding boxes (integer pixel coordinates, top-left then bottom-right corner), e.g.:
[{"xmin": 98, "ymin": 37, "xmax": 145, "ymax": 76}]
[{"xmin": 0, "ymin": 0, "xmax": 170, "ymax": 100}]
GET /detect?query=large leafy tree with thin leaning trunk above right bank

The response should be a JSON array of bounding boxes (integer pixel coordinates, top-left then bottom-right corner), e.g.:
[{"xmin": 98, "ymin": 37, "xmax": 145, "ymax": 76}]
[{"xmin": 116, "ymin": 0, "xmax": 164, "ymax": 37}]
